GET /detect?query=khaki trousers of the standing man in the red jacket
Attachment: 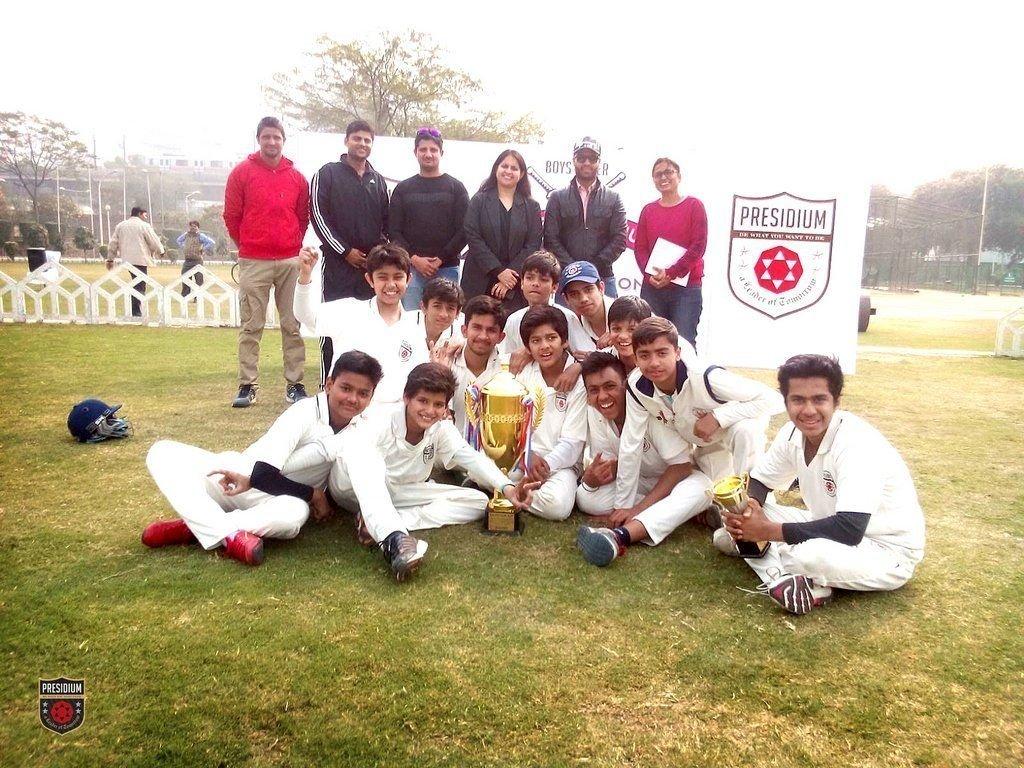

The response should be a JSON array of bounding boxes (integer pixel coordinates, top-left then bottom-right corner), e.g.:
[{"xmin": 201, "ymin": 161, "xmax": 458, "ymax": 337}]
[{"xmin": 239, "ymin": 256, "xmax": 306, "ymax": 384}]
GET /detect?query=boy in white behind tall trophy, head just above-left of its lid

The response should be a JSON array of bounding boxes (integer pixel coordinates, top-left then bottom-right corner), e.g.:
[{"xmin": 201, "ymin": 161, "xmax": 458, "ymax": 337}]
[{"xmin": 452, "ymin": 296, "xmax": 505, "ymax": 437}]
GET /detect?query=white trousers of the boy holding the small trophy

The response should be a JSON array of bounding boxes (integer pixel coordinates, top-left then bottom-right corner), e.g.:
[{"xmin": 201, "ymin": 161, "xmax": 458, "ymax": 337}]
[{"xmin": 746, "ymin": 499, "xmax": 918, "ymax": 592}]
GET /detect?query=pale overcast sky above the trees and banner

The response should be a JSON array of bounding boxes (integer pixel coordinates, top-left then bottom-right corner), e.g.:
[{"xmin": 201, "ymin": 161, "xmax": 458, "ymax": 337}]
[{"xmin": 0, "ymin": 0, "xmax": 1024, "ymax": 191}]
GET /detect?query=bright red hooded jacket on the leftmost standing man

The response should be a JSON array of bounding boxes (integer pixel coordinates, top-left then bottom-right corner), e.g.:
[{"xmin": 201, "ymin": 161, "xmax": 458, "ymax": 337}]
[{"xmin": 224, "ymin": 152, "xmax": 309, "ymax": 259}]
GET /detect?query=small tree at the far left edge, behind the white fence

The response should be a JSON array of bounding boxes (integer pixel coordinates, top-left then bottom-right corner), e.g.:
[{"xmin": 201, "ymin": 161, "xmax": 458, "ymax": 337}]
[{"xmin": 0, "ymin": 112, "xmax": 88, "ymax": 222}]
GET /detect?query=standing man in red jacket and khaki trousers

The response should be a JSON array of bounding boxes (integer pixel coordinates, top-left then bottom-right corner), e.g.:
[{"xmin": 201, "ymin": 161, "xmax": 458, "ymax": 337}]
[{"xmin": 224, "ymin": 118, "xmax": 309, "ymax": 408}]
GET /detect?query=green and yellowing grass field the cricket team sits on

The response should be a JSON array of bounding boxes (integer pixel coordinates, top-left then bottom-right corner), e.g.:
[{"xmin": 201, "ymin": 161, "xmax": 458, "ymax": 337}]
[{"xmin": 0, "ymin": 315, "xmax": 1024, "ymax": 768}]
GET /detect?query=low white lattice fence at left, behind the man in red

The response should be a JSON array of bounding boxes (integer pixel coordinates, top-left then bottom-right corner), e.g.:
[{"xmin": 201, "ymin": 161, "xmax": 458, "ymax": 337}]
[{"xmin": 0, "ymin": 263, "xmax": 278, "ymax": 328}]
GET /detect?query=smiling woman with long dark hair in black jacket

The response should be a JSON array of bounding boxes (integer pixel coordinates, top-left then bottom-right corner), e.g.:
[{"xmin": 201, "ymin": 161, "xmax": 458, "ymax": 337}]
[{"xmin": 462, "ymin": 150, "xmax": 544, "ymax": 312}]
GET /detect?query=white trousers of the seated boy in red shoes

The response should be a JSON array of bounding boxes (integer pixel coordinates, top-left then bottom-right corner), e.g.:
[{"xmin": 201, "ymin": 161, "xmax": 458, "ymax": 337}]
[{"xmin": 145, "ymin": 440, "xmax": 309, "ymax": 549}]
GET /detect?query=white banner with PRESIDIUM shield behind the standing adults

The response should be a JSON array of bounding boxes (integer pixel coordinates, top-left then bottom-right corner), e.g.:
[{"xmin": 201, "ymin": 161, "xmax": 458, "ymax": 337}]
[{"xmin": 286, "ymin": 133, "xmax": 869, "ymax": 373}]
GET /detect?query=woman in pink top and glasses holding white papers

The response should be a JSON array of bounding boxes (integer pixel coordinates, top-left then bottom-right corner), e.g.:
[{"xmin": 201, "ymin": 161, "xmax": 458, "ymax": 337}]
[{"xmin": 633, "ymin": 158, "xmax": 708, "ymax": 345}]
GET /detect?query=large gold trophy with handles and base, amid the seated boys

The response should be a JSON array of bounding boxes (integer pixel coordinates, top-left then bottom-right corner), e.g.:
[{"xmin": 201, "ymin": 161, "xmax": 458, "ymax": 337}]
[{"xmin": 466, "ymin": 365, "xmax": 544, "ymax": 534}]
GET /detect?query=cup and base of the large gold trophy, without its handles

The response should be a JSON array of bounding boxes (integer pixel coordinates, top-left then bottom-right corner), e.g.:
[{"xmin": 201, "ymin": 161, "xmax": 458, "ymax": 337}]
[{"xmin": 479, "ymin": 367, "xmax": 528, "ymax": 534}]
